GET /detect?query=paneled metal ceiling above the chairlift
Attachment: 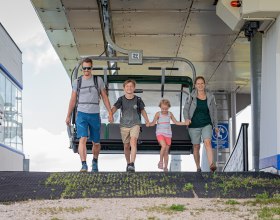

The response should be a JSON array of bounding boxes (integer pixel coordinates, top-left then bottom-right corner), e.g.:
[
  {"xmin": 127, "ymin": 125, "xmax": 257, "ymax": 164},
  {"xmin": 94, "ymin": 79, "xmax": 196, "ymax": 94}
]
[{"xmin": 31, "ymin": 0, "xmax": 250, "ymax": 93}]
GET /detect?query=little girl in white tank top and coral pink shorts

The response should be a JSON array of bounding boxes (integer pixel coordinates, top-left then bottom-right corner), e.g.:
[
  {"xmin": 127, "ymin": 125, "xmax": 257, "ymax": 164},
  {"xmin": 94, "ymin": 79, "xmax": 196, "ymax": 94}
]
[{"xmin": 150, "ymin": 99, "xmax": 186, "ymax": 171}]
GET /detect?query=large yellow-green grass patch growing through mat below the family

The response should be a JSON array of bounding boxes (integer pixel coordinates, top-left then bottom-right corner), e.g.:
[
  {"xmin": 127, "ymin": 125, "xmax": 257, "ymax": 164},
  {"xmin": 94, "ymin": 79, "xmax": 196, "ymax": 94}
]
[{"xmin": 45, "ymin": 173, "xmax": 182, "ymax": 198}]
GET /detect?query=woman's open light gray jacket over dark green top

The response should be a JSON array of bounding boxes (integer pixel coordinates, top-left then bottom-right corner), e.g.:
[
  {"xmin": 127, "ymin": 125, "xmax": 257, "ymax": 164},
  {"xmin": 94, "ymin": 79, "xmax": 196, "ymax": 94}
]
[{"xmin": 183, "ymin": 89, "xmax": 218, "ymax": 128}]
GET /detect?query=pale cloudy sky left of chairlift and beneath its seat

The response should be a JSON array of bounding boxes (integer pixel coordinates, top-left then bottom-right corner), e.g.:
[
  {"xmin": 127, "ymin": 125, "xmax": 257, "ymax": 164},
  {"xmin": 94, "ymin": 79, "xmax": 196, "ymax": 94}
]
[{"xmin": 0, "ymin": 0, "xmax": 199, "ymax": 171}]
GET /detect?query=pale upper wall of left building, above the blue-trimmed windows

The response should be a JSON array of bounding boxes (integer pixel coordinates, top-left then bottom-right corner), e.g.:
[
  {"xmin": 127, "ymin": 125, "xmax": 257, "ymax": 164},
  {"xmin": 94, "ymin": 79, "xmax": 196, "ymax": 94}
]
[{"xmin": 0, "ymin": 23, "xmax": 22, "ymax": 85}]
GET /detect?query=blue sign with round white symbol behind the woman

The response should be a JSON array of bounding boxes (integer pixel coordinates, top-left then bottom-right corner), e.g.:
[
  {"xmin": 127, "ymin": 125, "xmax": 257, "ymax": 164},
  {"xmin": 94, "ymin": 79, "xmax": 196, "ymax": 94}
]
[{"xmin": 211, "ymin": 123, "xmax": 229, "ymax": 148}]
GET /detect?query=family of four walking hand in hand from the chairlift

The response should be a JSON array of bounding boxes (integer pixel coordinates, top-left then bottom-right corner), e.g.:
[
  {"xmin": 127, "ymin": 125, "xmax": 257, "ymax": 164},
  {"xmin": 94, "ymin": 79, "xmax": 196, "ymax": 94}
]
[{"xmin": 66, "ymin": 58, "xmax": 218, "ymax": 172}]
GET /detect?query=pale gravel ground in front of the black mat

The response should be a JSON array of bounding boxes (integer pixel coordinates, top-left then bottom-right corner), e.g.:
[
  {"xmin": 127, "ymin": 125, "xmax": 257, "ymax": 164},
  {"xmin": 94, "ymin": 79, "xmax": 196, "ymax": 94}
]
[{"xmin": 0, "ymin": 198, "xmax": 266, "ymax": 220}]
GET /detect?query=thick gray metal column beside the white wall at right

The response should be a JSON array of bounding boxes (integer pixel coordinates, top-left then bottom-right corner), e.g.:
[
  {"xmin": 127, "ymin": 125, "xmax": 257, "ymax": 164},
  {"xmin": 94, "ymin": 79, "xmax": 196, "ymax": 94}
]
[{"xmin": 250, "ymin": 32, "xmax": 262, "ymax": 171}]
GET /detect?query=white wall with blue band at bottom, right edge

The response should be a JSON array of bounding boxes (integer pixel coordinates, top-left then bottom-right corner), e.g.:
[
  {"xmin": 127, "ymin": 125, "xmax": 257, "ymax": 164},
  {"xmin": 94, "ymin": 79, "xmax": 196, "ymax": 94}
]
[{"xmin": 260, "ymin": 16, "xmax": 280, "ymax": 170}]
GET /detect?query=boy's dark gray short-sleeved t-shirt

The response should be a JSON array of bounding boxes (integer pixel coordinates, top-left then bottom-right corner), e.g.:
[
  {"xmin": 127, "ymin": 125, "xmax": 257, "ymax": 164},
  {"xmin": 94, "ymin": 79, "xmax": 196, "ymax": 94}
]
[{"xmin": 114, "ymin": 96, "xmax": 145, "ymax": 128}]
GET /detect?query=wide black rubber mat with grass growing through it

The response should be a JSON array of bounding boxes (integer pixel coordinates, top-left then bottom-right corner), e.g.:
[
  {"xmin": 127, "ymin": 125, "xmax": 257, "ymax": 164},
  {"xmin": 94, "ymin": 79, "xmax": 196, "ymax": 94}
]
[{"xmin": 0, "ymin": 172, "xmax": 280, "ymax": 202}]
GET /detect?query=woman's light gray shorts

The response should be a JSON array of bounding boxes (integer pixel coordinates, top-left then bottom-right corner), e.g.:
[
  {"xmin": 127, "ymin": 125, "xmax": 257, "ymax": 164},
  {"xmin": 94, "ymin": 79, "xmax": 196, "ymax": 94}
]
[{"xmin": 189, "ymin": 125, "xmax": 212, "ymax": 144}]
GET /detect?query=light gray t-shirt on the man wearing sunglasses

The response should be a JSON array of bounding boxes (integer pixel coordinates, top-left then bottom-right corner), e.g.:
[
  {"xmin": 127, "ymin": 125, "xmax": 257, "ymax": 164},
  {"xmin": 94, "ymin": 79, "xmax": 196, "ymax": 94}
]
[{"xmin": 72, "ymin": 76, "xmax": 104, "ymax": 113}]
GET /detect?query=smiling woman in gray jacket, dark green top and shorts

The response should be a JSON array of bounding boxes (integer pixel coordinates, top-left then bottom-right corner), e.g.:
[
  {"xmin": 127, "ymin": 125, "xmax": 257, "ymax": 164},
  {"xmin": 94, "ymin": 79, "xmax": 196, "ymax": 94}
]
[{"xmin": 183, "ymin": 76, "xmax": 219, "ymax": 172}]
